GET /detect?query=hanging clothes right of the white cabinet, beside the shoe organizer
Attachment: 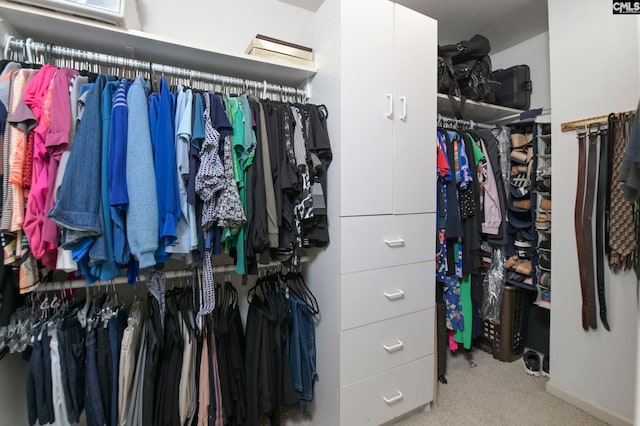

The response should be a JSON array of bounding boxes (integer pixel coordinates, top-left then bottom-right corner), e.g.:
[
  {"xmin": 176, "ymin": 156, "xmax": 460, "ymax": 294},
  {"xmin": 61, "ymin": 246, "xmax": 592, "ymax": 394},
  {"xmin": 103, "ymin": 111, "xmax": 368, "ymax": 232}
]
[{"xmin": 436, "ymin": 125, "xmax": 507, "ymax": 352}]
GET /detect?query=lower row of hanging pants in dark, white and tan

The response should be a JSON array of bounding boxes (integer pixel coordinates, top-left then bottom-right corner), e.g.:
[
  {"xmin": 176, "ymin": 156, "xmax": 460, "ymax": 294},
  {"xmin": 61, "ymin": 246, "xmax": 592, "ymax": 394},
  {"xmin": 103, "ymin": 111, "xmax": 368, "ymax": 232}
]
[{"xmin": 3, "ymin": 272, "xmax": 320, "ymax": 426}]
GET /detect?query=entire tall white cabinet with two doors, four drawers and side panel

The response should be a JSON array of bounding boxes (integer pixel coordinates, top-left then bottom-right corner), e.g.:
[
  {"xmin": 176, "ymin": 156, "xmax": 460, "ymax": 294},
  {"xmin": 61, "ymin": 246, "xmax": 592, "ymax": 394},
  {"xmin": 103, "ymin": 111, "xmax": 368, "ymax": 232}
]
[{"xmin": 307, "ymin": 0, "xmax": 437, "ymax": 426}]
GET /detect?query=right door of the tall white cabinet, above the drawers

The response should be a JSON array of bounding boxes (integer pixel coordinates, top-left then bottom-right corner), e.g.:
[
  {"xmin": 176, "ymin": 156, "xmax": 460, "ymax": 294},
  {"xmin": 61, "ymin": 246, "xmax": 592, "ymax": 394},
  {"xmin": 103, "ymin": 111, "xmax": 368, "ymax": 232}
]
[{"xmin": 393, "ymin": 4, "xmax": 438, "ymax": 214}]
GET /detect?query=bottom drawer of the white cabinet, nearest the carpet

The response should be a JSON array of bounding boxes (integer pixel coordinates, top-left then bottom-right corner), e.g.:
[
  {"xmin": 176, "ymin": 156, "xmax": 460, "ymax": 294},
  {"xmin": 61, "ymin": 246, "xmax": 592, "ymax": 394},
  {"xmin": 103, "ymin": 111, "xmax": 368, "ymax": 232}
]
[{"xmin": 340, "ymin": 355, "xmax": 434, "ymax": 426}]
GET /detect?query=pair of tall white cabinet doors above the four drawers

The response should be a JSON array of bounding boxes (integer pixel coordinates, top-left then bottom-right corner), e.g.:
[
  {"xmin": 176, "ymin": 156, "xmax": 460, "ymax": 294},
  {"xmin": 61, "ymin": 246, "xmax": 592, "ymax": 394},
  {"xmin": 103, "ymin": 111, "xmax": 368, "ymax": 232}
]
[{"xmin": 339, "ymin": 0, "xmax": 437, "ymax": 216}]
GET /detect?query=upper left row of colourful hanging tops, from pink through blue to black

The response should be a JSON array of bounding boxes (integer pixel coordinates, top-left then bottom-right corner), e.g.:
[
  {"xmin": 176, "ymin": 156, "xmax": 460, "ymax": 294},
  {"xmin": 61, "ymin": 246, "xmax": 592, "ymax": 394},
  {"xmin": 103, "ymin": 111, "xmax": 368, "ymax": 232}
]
[{"xmin": 2, "ymin": 64, "xmax": 331, "ymax": 283}]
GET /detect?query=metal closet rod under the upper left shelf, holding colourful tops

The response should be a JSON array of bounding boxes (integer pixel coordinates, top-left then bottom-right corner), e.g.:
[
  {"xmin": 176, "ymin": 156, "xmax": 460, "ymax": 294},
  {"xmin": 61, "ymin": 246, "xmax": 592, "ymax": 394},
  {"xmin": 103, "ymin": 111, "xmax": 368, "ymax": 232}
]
[{"xmin": 4, "ymin": 35, "xmax": 309, "ymax": 99}]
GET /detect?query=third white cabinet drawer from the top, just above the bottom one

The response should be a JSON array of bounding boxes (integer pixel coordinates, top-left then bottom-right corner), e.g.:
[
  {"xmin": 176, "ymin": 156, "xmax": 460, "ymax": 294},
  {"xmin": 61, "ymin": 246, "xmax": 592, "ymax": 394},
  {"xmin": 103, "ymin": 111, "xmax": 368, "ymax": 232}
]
[{"xmin": 340, "ymin": 308, "xmax": 434, "ymax": 385}]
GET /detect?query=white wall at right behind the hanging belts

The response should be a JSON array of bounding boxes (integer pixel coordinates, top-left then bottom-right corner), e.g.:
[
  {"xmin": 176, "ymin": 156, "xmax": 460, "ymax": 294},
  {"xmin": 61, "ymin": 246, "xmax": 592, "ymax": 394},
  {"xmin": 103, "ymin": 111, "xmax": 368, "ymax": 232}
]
[{"xmin": 547, "ymin": 0, "xmax": 639, "ymax": 424}]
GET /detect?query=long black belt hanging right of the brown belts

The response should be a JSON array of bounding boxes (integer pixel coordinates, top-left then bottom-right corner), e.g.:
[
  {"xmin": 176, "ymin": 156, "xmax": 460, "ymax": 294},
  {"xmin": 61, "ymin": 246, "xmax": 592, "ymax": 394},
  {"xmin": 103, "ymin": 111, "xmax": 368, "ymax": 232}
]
[{"xmin": 587, "ymin": 130, "xmax": 609, "ymax": 331}]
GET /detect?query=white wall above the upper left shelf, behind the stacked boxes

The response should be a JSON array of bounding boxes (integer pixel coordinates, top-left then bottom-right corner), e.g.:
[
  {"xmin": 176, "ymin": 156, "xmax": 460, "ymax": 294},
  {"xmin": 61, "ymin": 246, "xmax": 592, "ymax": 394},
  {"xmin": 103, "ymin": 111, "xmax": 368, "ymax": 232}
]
[{"xmin": 139, "ymin": 0, "xmax": 313, "ymax": 53}]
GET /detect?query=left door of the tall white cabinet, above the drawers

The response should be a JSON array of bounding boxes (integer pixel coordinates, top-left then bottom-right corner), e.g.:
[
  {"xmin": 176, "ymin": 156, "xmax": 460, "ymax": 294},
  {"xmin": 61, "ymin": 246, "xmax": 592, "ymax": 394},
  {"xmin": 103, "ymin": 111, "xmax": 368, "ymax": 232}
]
[{"xmin": 340, "ymin": 0, "xmax": 395, "ymax": 216}]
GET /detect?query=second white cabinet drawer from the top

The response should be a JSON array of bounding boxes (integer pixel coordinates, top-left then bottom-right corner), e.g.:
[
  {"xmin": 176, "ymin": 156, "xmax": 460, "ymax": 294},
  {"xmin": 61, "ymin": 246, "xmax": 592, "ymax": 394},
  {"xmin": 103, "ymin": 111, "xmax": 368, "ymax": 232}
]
[{"xmin": 340, "ymin": 261, "xmax": 435, "ymax": 330}]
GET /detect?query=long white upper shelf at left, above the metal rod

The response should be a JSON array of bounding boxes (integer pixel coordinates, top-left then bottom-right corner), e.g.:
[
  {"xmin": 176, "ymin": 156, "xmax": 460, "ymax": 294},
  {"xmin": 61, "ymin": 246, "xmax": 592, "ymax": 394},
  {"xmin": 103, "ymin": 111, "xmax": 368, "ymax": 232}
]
[{"xmin": 0, "ymin": 1, "xmax": 316, "ymax": 87}]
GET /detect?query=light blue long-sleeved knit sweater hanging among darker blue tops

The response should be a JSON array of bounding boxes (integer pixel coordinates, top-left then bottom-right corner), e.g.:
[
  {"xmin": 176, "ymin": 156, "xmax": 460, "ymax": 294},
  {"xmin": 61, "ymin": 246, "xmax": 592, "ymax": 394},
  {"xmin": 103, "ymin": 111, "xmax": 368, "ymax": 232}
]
[{"xmin": 126, "ymin": 77, "xmax": 158, "ymax": 268}]
